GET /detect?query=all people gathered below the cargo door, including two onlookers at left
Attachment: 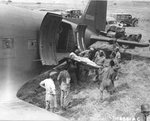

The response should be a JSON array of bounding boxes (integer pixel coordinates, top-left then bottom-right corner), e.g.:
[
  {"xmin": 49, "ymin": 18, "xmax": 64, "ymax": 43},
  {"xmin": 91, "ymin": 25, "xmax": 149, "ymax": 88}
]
[{"xmin": 40, "ymin": 46, "xmax": 150, "ymax": 120}]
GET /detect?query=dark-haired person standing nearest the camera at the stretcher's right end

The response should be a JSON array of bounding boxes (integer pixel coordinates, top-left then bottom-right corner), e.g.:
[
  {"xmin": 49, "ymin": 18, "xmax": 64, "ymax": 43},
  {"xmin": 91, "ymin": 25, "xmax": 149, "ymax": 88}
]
[{"xmin": 100, "ymin": 60, "xmax": 115, "ymax": 100}]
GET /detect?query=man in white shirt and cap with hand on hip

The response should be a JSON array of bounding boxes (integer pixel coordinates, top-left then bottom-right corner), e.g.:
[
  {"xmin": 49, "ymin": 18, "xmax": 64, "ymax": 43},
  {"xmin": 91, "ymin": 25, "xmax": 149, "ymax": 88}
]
[{"xmin": 40, "ymin": 72, "xmax": 57, "ymax": 112}]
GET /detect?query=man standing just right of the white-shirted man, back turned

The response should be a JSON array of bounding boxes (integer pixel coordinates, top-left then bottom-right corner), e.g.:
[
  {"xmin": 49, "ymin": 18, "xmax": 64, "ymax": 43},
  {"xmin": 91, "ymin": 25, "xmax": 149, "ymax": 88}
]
[{"xmin": 57, "ymin": 70, "xmax": 71, "ymax": 110}]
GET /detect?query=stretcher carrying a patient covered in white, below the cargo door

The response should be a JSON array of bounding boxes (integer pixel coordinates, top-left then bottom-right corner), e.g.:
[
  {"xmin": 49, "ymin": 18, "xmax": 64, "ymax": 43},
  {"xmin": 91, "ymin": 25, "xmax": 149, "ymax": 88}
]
[{"xmin": 69, "ymin": 52, "xmax": 100, "ymax": 69}]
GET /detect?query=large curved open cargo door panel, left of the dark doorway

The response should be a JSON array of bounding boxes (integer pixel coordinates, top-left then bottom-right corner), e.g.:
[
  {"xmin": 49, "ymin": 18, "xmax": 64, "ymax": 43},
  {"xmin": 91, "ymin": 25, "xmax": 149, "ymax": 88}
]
[{"xmin": 39, "ymin": 13, "xmax": 62, "ymax": 65}]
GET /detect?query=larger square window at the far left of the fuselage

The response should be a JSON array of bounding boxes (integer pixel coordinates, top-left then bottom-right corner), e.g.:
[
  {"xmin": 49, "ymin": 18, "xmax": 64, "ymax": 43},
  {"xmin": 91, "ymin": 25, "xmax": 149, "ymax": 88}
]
[{"xmin": 2, "ymin": 38, "xmax": 14, "ymax": 49}]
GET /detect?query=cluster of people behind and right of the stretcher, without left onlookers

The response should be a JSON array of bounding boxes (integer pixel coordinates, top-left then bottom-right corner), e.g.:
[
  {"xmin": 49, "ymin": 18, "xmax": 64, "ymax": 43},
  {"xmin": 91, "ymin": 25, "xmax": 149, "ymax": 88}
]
[{"xmin": 76, "ymin": 46, "xmax": 121, "ymax": 100}]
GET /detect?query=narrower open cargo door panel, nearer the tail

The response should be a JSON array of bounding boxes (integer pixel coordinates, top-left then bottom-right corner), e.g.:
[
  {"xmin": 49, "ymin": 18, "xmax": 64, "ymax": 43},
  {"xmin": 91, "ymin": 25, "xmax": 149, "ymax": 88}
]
[{"xmin": 75, "ymin": 24, "xmax": 87, "ymax": 51}]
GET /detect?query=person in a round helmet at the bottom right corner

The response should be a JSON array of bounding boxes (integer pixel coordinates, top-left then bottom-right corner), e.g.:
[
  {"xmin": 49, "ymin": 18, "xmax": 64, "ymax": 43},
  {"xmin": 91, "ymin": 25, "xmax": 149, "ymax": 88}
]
[{"xmin": 135, "ymin": 104, "xmax": 150, "ymax": 121}]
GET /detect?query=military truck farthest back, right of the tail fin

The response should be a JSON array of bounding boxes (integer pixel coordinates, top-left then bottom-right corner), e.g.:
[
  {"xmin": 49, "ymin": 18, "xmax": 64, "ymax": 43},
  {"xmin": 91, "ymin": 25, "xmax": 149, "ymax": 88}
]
[{"xmin": 111, "ymin": 13, "xmax": 138, "ymax": 27}]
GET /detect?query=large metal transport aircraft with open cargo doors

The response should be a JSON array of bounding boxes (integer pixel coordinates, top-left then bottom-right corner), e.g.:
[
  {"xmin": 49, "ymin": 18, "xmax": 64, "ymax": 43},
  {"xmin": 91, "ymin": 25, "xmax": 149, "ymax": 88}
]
[{"xmin": 0, "ymin": 0, "xmax": 149, "ymax": 121}]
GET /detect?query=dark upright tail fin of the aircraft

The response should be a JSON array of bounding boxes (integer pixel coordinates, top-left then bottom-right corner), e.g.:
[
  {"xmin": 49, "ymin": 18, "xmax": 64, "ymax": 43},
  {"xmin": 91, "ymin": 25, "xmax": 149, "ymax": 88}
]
[{"xmin": 81, "ymin": 0, "xmax": 107, "ymax": 33}]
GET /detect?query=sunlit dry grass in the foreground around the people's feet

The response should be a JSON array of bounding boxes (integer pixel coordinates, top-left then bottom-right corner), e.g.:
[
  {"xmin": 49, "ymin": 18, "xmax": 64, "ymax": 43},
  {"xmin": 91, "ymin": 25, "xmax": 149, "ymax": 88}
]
[{"xmin": 17, "ymin": 60, "xmax": 150, "ymax": 121}]
